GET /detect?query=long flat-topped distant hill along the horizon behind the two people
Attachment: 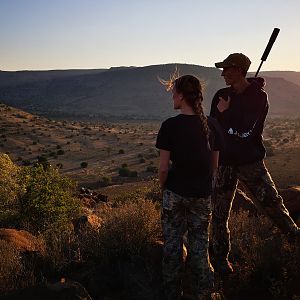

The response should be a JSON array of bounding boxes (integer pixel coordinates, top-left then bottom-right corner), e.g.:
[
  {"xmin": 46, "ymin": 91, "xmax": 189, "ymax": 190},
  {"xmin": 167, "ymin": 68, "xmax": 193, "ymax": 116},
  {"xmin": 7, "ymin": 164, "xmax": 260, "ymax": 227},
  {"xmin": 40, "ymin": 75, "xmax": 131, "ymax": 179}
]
[{"xmin": 0, "ymin": 64, "xmax": 300, "ymax": 119}]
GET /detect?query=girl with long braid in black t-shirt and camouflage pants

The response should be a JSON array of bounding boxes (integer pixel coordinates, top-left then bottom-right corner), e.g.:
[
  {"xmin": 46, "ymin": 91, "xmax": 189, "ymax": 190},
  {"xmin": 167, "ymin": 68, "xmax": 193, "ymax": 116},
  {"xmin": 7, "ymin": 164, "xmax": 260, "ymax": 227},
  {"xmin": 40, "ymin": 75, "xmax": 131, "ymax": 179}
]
[{"xmin": 156, "ymin": 75, "xmax": 218, "ymax": 300}]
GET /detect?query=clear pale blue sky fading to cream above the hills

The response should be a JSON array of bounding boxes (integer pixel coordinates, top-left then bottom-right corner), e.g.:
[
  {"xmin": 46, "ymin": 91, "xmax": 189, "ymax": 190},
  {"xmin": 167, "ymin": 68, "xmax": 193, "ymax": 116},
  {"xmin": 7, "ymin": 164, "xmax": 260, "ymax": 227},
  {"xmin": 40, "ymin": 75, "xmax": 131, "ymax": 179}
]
[{"xmin": 0, "ymin": 0, "xmax": 300, "ymax": 71}]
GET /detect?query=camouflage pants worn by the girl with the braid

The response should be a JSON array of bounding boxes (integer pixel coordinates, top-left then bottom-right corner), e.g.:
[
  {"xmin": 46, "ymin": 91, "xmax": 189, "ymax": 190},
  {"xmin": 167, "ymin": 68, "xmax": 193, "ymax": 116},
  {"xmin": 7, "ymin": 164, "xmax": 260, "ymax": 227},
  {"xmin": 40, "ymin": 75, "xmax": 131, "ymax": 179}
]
[{"xmin": 162, "ymin": 190, "xmax": 213, "ymax": 300}]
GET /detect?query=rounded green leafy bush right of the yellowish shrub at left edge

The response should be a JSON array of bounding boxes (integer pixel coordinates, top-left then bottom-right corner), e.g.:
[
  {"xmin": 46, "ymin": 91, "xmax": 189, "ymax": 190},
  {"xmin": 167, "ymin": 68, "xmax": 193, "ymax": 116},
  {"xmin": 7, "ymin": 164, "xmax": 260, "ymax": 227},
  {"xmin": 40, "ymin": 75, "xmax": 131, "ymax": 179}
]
[{"xmin": 19, "ymin": 164, "xmax": 80, "ymax": 233}]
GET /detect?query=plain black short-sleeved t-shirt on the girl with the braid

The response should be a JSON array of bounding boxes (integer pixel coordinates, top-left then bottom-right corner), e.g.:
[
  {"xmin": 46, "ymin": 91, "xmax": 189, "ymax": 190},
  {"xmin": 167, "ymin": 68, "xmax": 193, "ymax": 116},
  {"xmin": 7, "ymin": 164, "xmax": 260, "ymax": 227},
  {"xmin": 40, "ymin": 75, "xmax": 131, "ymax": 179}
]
[{"xmin": 156, "ymin": 114, "xmax": 219, "ymax": 197}]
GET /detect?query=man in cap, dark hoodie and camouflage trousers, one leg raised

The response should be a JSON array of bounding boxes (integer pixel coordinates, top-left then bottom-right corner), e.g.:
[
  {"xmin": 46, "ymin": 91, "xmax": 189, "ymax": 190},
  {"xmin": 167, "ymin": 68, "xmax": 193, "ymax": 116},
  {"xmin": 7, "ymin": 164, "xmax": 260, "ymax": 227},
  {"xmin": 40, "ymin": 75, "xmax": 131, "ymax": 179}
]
[{"xmin": 210, "ymin": 53, "xmax": 300, "ymax": 275}]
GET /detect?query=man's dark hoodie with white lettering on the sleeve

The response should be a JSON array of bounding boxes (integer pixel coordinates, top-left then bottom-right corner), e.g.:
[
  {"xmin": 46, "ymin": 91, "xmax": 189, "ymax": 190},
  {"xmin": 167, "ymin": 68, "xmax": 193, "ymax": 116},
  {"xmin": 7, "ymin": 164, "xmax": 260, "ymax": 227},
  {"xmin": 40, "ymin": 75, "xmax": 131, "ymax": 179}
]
[{"xmin": 210, "ymin": 78, "xmax": 269, "ymax": 165}]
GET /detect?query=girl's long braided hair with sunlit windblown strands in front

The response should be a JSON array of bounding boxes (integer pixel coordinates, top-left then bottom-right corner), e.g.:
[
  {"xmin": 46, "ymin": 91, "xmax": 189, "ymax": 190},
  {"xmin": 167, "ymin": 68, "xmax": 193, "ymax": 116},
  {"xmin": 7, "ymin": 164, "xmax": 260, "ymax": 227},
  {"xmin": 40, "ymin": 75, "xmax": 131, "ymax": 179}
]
[{"xmin": 160, "ymin": 70, "xmax": 209, "ymax": 137}]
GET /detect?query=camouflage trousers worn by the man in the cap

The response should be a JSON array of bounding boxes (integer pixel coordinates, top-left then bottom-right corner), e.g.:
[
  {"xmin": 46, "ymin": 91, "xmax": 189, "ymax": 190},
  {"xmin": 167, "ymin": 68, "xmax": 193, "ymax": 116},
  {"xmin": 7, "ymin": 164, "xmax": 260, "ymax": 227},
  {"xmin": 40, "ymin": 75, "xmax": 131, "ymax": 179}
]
[{"xmin": 212, "ymin": 161, "xmax": 299, "ymax": 269}]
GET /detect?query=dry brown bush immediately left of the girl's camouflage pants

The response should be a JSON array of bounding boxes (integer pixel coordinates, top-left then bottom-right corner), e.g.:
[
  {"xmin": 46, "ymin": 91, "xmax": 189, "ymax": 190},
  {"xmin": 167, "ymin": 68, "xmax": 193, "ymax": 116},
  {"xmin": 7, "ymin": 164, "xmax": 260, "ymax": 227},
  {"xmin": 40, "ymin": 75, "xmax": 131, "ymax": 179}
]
[{"xmin": 99, "ymin": 199, "xmax": 161, "ymax": 259}]
